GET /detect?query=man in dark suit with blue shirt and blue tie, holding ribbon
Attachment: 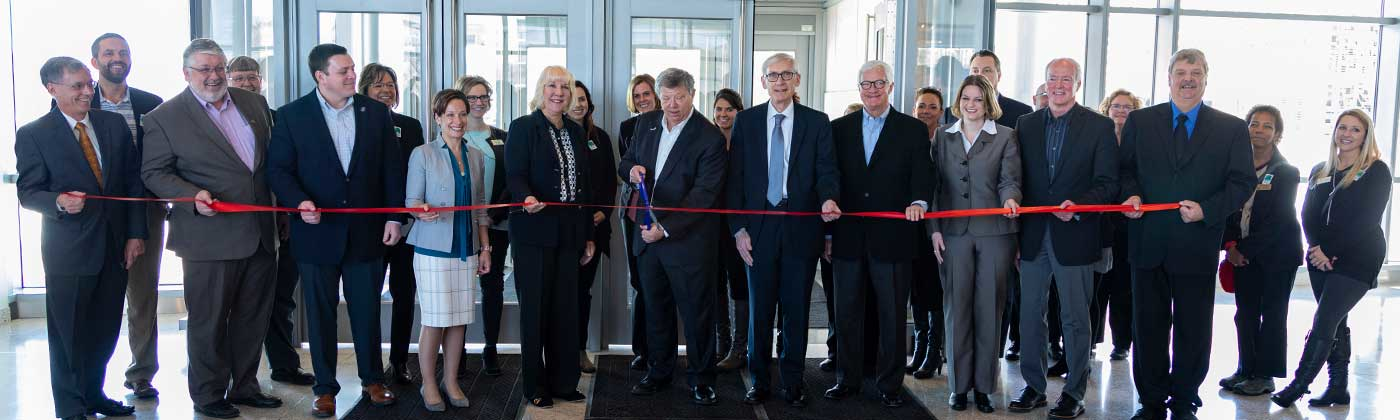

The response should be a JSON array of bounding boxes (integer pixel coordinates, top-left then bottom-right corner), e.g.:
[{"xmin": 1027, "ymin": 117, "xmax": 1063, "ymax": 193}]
[{"xmin": 1119, "ymin": 49, "xmax": 1257, "ymax": 420}]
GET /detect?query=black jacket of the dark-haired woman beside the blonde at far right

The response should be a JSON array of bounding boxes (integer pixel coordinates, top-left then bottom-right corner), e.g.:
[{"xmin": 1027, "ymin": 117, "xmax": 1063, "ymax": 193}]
[{"xmin": 1222, "ymin": 148, "xmax": 1304, "ymax": 272}]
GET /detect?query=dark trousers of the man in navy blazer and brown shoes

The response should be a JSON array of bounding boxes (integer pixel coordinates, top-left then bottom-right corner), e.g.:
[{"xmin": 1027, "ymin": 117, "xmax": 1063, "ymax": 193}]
[{"xmin": 298, "ymin": 259, "xmax": 384, "ymax": 395}]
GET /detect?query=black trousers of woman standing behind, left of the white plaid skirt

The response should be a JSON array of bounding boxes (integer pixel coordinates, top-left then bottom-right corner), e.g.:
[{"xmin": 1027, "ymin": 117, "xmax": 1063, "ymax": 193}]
[{"xmin": 379, "ymin": 242, "xmax": 419, "ymax": 365}]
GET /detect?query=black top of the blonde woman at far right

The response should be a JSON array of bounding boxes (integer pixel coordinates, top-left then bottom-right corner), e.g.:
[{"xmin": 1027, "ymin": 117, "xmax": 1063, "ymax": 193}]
[{"xmin": 1303, "ymin": 161, "xmax": 1392, "ymax": 288}]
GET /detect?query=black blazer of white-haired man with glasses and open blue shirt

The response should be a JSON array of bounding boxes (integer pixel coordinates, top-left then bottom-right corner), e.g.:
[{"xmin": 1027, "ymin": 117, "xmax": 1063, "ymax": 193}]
[{"xmin": 832, "ymin": 108, "xmax": 935, "ymax": 262}]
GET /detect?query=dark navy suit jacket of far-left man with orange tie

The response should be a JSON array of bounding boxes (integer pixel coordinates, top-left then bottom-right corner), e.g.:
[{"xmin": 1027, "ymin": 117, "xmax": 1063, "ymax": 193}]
[{"xmin": 14, "ymin": 109, "xmax": 146, "ymax": 277}]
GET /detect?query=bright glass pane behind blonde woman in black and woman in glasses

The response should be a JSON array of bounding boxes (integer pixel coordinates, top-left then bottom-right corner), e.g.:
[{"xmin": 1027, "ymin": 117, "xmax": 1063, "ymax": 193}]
[{"xmin": 462, "ymin": 14, "xmax": 568, "ymax": 127}]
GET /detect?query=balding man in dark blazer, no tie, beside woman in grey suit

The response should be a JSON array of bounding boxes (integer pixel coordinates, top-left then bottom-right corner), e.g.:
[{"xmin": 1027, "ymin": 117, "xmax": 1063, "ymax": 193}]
[{"xmin": 1008, "ymin": 59, "xmax": 1119, "ymax": 419}]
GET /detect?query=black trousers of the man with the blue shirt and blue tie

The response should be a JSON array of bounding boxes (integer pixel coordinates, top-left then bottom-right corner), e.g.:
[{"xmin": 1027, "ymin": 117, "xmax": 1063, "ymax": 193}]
[{"xmin": 1133, "ymin": 266, "xmax": 1215, "ymax": 407}]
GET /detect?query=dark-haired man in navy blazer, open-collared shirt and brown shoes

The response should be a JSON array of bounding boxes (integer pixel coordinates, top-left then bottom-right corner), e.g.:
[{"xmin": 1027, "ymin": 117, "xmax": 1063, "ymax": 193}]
[{"xmin": 267, "ymin": 43, "xmax": 406, "ymax": 417}]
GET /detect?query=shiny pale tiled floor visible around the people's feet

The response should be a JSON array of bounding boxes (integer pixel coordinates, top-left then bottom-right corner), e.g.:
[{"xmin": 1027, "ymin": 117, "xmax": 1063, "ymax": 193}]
[{"xmin": 0, "ymin": 284, "xmax": 1400, "ymax": 420}]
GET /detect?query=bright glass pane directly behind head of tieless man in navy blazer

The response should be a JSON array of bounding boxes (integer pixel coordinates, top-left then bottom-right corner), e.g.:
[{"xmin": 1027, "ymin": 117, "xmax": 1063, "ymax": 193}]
[{"xmin": 319, "ymin": 13, "xmax": 424, "ymax": 120}]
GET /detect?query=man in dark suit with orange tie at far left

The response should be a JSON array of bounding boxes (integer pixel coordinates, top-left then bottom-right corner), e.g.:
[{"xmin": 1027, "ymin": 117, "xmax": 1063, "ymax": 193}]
[{"xmin": 14, "ymin": 57, "xmax": 146, "ymax": 420}]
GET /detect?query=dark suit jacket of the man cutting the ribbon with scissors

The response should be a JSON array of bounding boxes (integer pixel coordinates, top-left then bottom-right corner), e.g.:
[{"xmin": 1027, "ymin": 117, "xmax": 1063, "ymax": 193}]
[{"xmin": 617, "ymin": 111, "xmax": 728, "ymax": 263}]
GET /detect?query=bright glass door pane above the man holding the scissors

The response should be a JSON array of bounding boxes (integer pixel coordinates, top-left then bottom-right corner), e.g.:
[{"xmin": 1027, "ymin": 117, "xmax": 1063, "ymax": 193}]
[{"xmin": 631, "ymin": 18, "xmax": 732, "ymax": 113}]
